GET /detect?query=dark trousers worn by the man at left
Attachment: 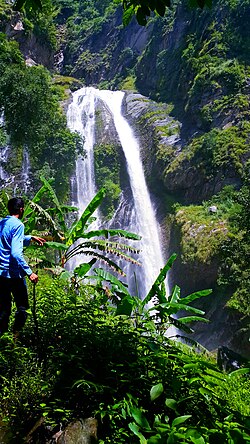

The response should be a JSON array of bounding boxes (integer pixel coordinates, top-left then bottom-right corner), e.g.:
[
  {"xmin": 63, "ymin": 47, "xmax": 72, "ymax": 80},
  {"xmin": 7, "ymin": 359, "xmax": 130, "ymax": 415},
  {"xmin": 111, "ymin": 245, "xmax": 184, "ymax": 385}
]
[{"xmin": 0, "ymin": 276, "xmax": 29, "ymax": 334}]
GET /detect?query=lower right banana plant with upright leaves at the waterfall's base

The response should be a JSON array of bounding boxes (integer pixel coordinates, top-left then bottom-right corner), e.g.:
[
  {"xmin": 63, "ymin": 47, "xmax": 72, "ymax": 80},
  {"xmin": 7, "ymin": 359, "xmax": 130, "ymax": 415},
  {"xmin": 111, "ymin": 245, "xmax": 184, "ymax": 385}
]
[{"xmin": 92, "ymin": 254, "xmax": 212, "ymax": 338}]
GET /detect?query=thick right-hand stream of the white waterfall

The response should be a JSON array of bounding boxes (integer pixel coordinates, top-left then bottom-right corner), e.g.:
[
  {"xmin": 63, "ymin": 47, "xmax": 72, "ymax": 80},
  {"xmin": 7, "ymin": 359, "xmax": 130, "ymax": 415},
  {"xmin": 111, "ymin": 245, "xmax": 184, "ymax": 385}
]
[{"xmin": 96, "ymin": 91, "xmax": 164, "ymax": 296}]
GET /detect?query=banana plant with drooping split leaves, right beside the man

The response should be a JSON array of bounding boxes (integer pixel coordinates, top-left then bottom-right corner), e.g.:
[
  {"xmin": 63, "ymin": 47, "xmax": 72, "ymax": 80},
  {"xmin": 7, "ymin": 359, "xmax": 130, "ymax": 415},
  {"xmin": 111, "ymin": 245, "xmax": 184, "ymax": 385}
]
[{"xmin": 24, "ymin": 178, "xmax": 141, "ymax": 277}]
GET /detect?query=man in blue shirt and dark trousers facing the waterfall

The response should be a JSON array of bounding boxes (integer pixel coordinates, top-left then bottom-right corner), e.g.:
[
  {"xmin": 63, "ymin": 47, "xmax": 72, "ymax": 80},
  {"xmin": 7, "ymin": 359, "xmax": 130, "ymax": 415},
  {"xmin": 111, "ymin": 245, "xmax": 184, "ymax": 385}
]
[{"xmin": 0, "ymin": 197, "xmax": 45, "ymax": 335}]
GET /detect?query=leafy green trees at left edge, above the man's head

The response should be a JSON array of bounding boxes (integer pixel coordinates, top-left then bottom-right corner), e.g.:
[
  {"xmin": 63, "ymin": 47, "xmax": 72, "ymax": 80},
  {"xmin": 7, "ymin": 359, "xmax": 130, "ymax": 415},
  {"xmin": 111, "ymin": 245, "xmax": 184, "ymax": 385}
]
[{"xmin": 0, "ymin": 34, "xmax": 83, "ymax": 199}]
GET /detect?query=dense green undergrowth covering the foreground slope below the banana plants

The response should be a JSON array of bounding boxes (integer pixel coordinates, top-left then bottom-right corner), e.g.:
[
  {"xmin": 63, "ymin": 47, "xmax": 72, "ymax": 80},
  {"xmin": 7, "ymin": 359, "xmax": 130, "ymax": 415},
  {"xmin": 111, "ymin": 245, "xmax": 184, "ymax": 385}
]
[{"xmin": 0, "ymin": 274, "xmax": 249, "ymax": 444}]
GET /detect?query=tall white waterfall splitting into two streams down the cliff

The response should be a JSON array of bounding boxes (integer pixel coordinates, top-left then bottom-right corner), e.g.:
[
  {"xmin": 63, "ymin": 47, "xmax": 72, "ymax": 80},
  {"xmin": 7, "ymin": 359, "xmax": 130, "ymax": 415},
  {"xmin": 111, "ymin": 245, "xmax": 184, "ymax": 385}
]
[{"xmin": 68, "ymin": 87, "xmax": 167, "ymax": 297}]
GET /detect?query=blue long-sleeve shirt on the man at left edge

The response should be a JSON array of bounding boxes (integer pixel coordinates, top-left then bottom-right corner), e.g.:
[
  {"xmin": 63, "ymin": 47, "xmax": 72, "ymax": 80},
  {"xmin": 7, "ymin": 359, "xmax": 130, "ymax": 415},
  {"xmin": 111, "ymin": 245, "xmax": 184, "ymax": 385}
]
[{"xmin": 0, "ymin": 216, "xmax": 32, "ymax": 278}]
